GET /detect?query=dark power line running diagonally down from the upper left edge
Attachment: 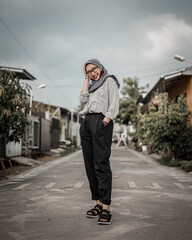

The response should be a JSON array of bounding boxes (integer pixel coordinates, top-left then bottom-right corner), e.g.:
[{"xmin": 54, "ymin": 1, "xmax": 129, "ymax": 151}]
[{"xmin": 0, "ymin": 17, "xmax": 72, "ymax": 107}]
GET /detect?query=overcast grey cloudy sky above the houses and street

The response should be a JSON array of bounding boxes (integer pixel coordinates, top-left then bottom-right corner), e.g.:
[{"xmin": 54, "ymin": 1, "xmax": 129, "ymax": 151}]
[{"xmin": 0, "ymin": 0, "xmax": 192, "ymax": 110}]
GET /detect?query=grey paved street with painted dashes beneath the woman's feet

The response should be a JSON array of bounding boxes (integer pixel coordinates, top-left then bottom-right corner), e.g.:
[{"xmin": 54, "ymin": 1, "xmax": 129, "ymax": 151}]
[{"xmin": 0, "ymin": 146, "xmax": 192, "ymax": 240}]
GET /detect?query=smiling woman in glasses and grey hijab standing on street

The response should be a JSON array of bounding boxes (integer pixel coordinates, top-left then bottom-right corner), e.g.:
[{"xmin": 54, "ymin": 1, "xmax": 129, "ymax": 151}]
[{"xmin": 79, "ymin": 59, "xmax": 120, "ymax": 224}]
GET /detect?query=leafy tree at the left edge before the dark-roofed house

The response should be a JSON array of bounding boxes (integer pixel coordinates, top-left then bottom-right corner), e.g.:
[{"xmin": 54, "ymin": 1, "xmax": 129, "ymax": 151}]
[{"xmin": 0, "ymin": 70, "xmax": 30, "ymax": 145}]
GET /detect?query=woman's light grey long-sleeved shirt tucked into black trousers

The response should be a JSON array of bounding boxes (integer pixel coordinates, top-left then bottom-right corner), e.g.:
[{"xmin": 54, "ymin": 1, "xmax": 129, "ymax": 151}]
[{"xmin": 79, "ymin": 77, "xmax": 119, "ymax": 119}]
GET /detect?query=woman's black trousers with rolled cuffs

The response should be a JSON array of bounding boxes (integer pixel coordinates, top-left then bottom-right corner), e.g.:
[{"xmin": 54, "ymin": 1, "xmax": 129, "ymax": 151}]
[{"xmin": 80, "ymin": 113, "xmax": 113, "ymax": 205}]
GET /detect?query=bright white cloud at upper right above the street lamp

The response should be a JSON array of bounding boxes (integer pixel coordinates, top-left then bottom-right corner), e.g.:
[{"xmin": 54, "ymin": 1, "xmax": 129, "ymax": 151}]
[{"xmin": 144, "ymin": 15, "xmax": 192, "ymax": 59}]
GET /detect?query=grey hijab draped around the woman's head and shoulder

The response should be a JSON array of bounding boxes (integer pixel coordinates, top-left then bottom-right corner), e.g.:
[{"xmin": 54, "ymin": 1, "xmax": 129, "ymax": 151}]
[{"xmin": 85, "ymin": 59, "xmax": 120, "ymax": 93}]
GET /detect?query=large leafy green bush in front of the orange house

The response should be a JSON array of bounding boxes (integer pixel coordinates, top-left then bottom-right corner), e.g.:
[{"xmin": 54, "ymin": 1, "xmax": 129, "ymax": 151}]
[{"xmin": 141, "ymin": 96, "xmax": 192, "ymax": 160}]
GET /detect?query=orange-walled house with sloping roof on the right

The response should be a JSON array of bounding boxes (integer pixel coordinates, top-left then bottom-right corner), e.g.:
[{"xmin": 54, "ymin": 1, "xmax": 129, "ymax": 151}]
[{"xmin": 141, "ymin": 67, "xmax": 192, "ymax": 121}]
